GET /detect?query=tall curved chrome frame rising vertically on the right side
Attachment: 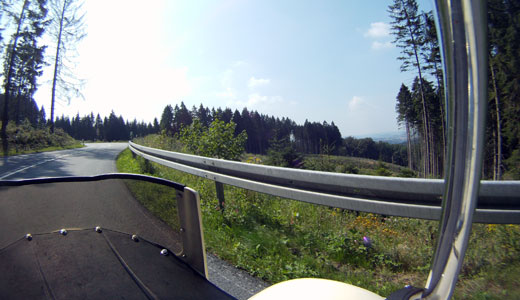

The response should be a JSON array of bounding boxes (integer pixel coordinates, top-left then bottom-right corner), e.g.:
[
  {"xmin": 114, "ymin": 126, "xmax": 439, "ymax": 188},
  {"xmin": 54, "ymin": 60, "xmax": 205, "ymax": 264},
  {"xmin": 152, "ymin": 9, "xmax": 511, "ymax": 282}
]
[{"xmin": 424, "ymin": 0, "xmax": 487, "ymax": 299}]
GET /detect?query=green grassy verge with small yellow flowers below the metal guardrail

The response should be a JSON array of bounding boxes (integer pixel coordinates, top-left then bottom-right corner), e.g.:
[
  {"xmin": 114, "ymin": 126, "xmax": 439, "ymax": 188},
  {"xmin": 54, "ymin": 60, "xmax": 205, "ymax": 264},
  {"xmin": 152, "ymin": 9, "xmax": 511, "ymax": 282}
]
[{"xmin": 118, "ymin": 137, "xmax": 520, "ymax": 299}]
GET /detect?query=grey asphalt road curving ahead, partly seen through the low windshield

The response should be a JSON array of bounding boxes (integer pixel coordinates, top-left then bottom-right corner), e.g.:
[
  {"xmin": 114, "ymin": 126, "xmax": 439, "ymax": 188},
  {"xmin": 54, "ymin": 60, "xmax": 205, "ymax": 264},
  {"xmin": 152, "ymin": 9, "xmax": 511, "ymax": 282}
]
[{"xmin": 0, "ymin": 143, "xmax": 268, "ymax": 299}]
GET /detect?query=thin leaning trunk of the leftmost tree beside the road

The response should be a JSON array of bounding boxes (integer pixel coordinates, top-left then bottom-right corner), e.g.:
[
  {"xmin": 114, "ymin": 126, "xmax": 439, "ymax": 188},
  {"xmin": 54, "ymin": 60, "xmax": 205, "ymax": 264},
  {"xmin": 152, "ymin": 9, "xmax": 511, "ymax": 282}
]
[{"xmin": 2, "ymin": 0, "xmax": 29, "ymax": 156}]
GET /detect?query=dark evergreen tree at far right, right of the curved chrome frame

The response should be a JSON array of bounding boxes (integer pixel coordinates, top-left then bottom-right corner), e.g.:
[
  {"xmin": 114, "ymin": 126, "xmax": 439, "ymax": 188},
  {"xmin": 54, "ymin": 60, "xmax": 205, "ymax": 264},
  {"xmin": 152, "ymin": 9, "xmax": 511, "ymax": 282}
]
[{"xmin": 484, "ymin": 0, "xmax": 520, "ymax": 180}]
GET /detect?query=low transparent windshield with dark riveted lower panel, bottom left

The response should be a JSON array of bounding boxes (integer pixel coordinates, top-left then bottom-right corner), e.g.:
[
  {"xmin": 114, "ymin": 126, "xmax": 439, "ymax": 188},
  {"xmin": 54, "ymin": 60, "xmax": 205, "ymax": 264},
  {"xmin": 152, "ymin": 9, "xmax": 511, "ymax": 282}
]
[{"xmin": 0, "ymin": 174, "xmax": 234, "ymax": 299}]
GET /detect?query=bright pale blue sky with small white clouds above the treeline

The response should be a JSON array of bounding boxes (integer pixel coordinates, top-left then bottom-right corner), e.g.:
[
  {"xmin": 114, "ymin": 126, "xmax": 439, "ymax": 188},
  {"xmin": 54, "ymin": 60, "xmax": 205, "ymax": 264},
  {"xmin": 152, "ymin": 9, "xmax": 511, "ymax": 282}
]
[{"xmin": 31, "ymin": 0, "xmax": 431, "ymax": 136}]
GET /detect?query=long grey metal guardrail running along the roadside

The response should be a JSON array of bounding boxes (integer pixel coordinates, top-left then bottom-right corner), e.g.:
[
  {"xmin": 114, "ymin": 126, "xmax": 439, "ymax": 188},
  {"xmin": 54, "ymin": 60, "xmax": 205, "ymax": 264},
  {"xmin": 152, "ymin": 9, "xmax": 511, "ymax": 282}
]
[{"xmin": 129, "ymin": 142, "xmax": 520, "ymax": 224}]
